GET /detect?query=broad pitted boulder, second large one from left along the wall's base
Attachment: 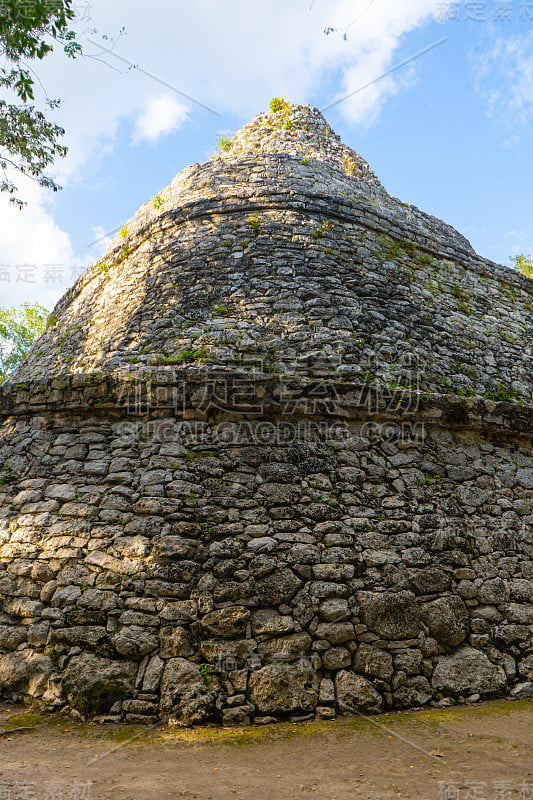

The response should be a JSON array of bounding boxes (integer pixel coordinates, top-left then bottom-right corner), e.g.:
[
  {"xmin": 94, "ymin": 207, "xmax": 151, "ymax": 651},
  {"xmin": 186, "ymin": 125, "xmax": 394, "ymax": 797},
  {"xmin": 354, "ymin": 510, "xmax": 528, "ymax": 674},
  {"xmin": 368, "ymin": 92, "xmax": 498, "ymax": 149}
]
[{"xmin": 62, "ymin": 653, "xmax": 137, "ymax": 714}]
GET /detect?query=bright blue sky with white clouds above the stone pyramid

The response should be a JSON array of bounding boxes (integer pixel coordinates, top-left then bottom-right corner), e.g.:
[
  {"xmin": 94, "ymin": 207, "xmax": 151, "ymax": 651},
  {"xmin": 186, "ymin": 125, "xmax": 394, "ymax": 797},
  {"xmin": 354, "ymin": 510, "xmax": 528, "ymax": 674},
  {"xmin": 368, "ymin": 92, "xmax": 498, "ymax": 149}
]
[{"xmin": 0, "ymin": 0, "xmax": 533, "ymax": 308}]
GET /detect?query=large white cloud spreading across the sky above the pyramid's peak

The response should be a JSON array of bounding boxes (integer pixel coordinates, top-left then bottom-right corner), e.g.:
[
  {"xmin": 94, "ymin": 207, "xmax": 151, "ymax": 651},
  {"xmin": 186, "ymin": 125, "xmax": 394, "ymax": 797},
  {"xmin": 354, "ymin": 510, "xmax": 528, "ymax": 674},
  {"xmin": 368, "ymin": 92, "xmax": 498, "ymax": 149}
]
[{"xmin": 36, "ymin": 0, "xmax": 441, "ymax": 170}]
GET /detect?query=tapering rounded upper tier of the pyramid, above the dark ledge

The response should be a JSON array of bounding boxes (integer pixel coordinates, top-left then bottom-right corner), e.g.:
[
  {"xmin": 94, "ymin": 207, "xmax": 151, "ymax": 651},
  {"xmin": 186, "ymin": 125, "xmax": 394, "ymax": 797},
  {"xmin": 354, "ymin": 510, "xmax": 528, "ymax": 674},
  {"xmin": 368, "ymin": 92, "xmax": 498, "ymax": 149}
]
[{"xmin": 14, "ymin": 101, "xmax": 532, "ymax": 406}]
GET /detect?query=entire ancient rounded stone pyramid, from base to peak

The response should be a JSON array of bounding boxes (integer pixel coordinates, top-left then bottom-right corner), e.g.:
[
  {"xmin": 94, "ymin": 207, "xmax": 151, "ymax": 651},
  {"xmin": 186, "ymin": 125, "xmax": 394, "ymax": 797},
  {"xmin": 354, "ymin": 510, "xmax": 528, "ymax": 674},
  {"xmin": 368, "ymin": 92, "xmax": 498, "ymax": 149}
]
[{"xmin": 0, "ymin": 106, "xmax": 533, "ymax": 724}]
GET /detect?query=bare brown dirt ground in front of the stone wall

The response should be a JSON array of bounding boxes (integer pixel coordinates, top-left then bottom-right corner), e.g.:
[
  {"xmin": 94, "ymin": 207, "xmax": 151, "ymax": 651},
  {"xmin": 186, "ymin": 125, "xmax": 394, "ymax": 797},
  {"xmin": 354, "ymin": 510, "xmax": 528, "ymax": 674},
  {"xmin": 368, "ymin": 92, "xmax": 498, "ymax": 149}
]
[{"xmin": 0, "ymin": 701, "xmax": 533, "ymax": 800}]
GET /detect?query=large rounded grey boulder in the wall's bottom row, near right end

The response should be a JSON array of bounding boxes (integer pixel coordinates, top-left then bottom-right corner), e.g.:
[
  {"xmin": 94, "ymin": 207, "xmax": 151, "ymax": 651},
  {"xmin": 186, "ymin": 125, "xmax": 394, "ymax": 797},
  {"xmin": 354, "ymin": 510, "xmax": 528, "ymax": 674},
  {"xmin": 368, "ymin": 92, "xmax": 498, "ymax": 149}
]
[{"xmin": 431, "ymin": 647, "xmax": 507, "ymax": 695}]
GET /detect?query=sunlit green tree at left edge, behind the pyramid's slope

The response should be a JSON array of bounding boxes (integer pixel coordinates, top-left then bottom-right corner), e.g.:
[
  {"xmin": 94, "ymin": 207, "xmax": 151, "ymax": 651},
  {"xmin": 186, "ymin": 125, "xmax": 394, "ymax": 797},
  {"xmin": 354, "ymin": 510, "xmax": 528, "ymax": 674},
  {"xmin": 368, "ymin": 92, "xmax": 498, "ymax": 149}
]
[{"xmin": 0, "ymin": 303, "xmax": 48, "ymax": 383}]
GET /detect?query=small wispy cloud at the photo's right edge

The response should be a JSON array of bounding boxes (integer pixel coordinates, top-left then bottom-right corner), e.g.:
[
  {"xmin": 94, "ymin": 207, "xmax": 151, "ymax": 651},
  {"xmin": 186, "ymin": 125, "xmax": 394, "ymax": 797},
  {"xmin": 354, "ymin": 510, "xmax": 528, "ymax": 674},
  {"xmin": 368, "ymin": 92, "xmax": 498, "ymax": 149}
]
[{"xmin": 474, "ymin": 32, "xmax": 533, "ymax": 126}]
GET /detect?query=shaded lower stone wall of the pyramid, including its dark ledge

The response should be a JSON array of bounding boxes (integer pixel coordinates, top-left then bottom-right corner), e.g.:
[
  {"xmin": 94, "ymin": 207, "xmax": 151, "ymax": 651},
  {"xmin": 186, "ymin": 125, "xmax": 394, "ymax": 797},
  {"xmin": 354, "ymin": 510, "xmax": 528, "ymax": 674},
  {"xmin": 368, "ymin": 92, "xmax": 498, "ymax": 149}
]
[{"xmin": 0, "ymin": 378, "xmax": 533, "ymax": 724}]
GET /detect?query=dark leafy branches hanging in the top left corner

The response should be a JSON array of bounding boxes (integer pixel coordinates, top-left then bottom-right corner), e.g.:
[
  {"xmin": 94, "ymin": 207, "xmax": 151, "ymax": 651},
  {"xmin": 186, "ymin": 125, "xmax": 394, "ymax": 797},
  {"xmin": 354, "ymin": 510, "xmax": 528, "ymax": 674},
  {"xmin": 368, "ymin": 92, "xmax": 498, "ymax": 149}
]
[{"xmin": 0, "ymin": 0, "xmax": 81, "ymax": 208}]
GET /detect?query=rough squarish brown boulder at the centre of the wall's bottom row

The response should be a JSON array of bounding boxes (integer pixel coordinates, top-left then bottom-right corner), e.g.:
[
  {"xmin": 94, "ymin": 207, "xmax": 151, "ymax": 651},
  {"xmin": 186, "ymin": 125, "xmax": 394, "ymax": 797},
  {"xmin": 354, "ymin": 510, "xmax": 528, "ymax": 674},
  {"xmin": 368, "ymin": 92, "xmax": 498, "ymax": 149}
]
[{"xmin": 249, "ymin": 664, "xmax": 318, "ymax": 714}]
